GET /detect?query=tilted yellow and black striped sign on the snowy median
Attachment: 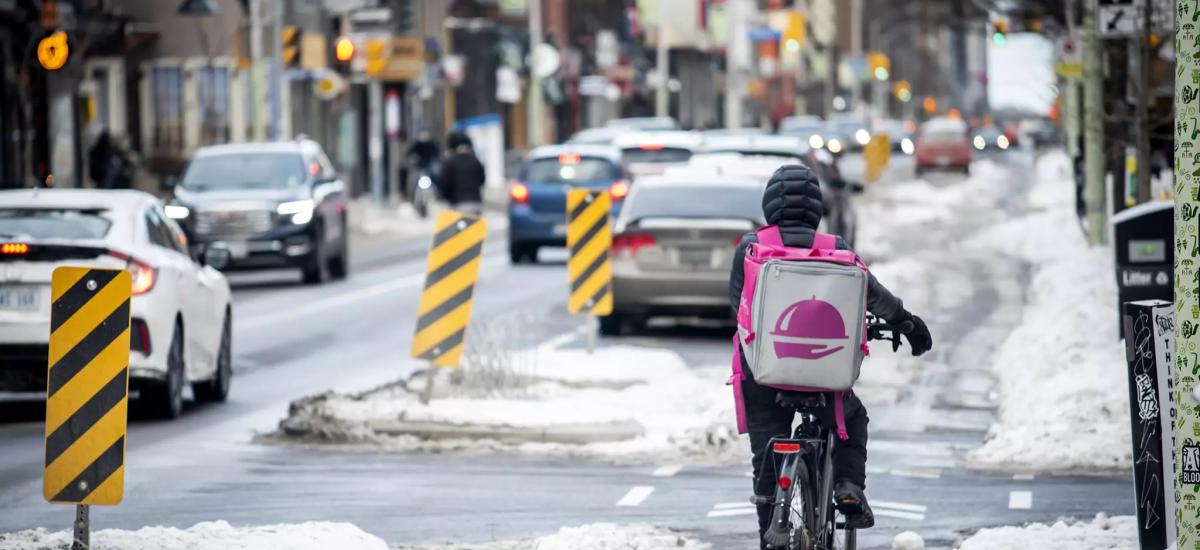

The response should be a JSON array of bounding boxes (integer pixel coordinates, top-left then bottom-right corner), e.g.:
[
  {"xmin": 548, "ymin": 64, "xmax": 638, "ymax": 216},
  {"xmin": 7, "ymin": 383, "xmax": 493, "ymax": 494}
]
[{"xmin": 413, "ymin": 211, "xmax": 487, "ymax": 366}]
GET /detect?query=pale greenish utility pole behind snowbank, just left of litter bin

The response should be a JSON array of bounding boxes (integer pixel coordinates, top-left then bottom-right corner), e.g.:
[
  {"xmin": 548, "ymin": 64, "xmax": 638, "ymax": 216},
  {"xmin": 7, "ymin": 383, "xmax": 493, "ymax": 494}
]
[{"xmin": 1084, "ymin": 0, "xmax": 1106, "ymax": 245}]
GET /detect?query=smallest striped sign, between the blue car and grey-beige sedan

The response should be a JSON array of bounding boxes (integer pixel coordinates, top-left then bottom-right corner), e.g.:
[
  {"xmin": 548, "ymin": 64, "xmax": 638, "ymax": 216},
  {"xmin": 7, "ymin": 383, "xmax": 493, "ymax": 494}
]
[{"xmin": 566, "ymin": 189, "xmax": 612, "ymax": 316}]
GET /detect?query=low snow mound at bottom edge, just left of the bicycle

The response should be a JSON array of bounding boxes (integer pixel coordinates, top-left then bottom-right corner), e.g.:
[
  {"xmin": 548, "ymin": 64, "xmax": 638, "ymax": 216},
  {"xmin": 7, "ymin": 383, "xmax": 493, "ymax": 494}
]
[{"xmin": 395, "ymin": 524, "xmax": 712, "ymax": 550}]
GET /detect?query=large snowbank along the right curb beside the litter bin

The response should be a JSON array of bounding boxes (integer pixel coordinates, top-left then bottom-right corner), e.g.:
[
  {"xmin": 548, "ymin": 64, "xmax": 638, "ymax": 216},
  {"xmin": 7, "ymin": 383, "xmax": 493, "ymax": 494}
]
[{"xmin": 966, "ymin": 154, "xmax": 1132, "ymax": 471}]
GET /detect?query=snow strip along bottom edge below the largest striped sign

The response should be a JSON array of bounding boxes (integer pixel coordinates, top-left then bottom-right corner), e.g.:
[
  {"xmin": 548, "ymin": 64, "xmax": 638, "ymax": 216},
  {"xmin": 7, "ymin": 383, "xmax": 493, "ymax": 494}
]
[{"xmin": 0, "ymin": 521, "xmax": 388, "ymax": 550}]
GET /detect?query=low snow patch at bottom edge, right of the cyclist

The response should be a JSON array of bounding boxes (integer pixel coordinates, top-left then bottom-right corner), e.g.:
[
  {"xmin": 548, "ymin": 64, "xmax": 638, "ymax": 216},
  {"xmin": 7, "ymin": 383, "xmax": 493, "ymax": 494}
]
[{"xmin": 959, "ymin": 514, "xmax": 1138, "ymax": 550}]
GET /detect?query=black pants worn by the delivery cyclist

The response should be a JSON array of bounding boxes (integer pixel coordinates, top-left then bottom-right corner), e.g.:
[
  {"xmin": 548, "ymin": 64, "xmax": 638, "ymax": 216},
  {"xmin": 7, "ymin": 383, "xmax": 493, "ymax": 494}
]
[{"xmin": 742, "ymin": 372, "xmax": 870, "ymax": 549}]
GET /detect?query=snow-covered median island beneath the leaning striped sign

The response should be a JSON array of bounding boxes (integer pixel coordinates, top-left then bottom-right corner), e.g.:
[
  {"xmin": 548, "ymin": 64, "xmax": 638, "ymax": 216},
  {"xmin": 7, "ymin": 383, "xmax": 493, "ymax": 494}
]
[{"xmin": 280, "ymin": 346, "xmax": 748, "ymax": 464}]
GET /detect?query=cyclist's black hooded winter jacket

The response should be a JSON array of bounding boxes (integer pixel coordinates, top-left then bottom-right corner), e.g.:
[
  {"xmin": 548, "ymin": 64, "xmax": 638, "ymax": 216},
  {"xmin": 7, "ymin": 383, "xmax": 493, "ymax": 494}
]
[{"xmin": 730, "ymin": 165, "xmax": 906, "ymax": 323}]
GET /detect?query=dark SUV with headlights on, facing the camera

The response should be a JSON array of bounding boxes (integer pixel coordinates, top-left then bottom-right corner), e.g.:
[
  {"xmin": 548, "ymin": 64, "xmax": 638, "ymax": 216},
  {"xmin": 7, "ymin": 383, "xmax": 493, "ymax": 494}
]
[{"xmin": 167, "ymin": 139, "xmax": 349, "ymax": 283}]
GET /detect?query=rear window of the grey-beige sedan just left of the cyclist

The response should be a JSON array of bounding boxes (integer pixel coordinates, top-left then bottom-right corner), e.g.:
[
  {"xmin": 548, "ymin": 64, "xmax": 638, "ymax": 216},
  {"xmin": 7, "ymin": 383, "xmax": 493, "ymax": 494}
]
[{"xmin": 623, "ymin": 185, "xmax": 762, "ymax": 221}]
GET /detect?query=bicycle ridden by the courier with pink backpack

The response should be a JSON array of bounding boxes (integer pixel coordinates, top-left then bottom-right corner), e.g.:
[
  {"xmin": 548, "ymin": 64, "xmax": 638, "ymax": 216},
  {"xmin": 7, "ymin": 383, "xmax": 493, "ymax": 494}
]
[{"xmin": 750, "ymin": 316, "xmax": 913, "ymax": 550}]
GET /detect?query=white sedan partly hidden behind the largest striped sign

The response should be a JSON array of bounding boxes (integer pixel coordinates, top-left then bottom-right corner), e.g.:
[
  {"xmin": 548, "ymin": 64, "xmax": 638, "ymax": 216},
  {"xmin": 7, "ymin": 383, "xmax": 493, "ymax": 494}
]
[{"xmin": 0, "ymin": 190, "xmax": 233, "ymax": 418}]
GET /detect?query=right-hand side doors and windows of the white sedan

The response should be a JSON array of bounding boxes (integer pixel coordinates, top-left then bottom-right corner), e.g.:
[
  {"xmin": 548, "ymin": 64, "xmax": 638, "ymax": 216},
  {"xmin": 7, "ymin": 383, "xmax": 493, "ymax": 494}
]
[{"xmin": 145, "ymin": 204, "xmax": 220, "ymax": 378}]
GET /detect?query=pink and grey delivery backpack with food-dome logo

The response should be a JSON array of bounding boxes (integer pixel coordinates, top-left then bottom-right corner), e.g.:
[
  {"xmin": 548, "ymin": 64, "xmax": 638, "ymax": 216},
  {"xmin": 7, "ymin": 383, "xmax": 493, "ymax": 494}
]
[{"xmin": 730, "ymin": 226, "xmax": 869, "ymax": 440}]
